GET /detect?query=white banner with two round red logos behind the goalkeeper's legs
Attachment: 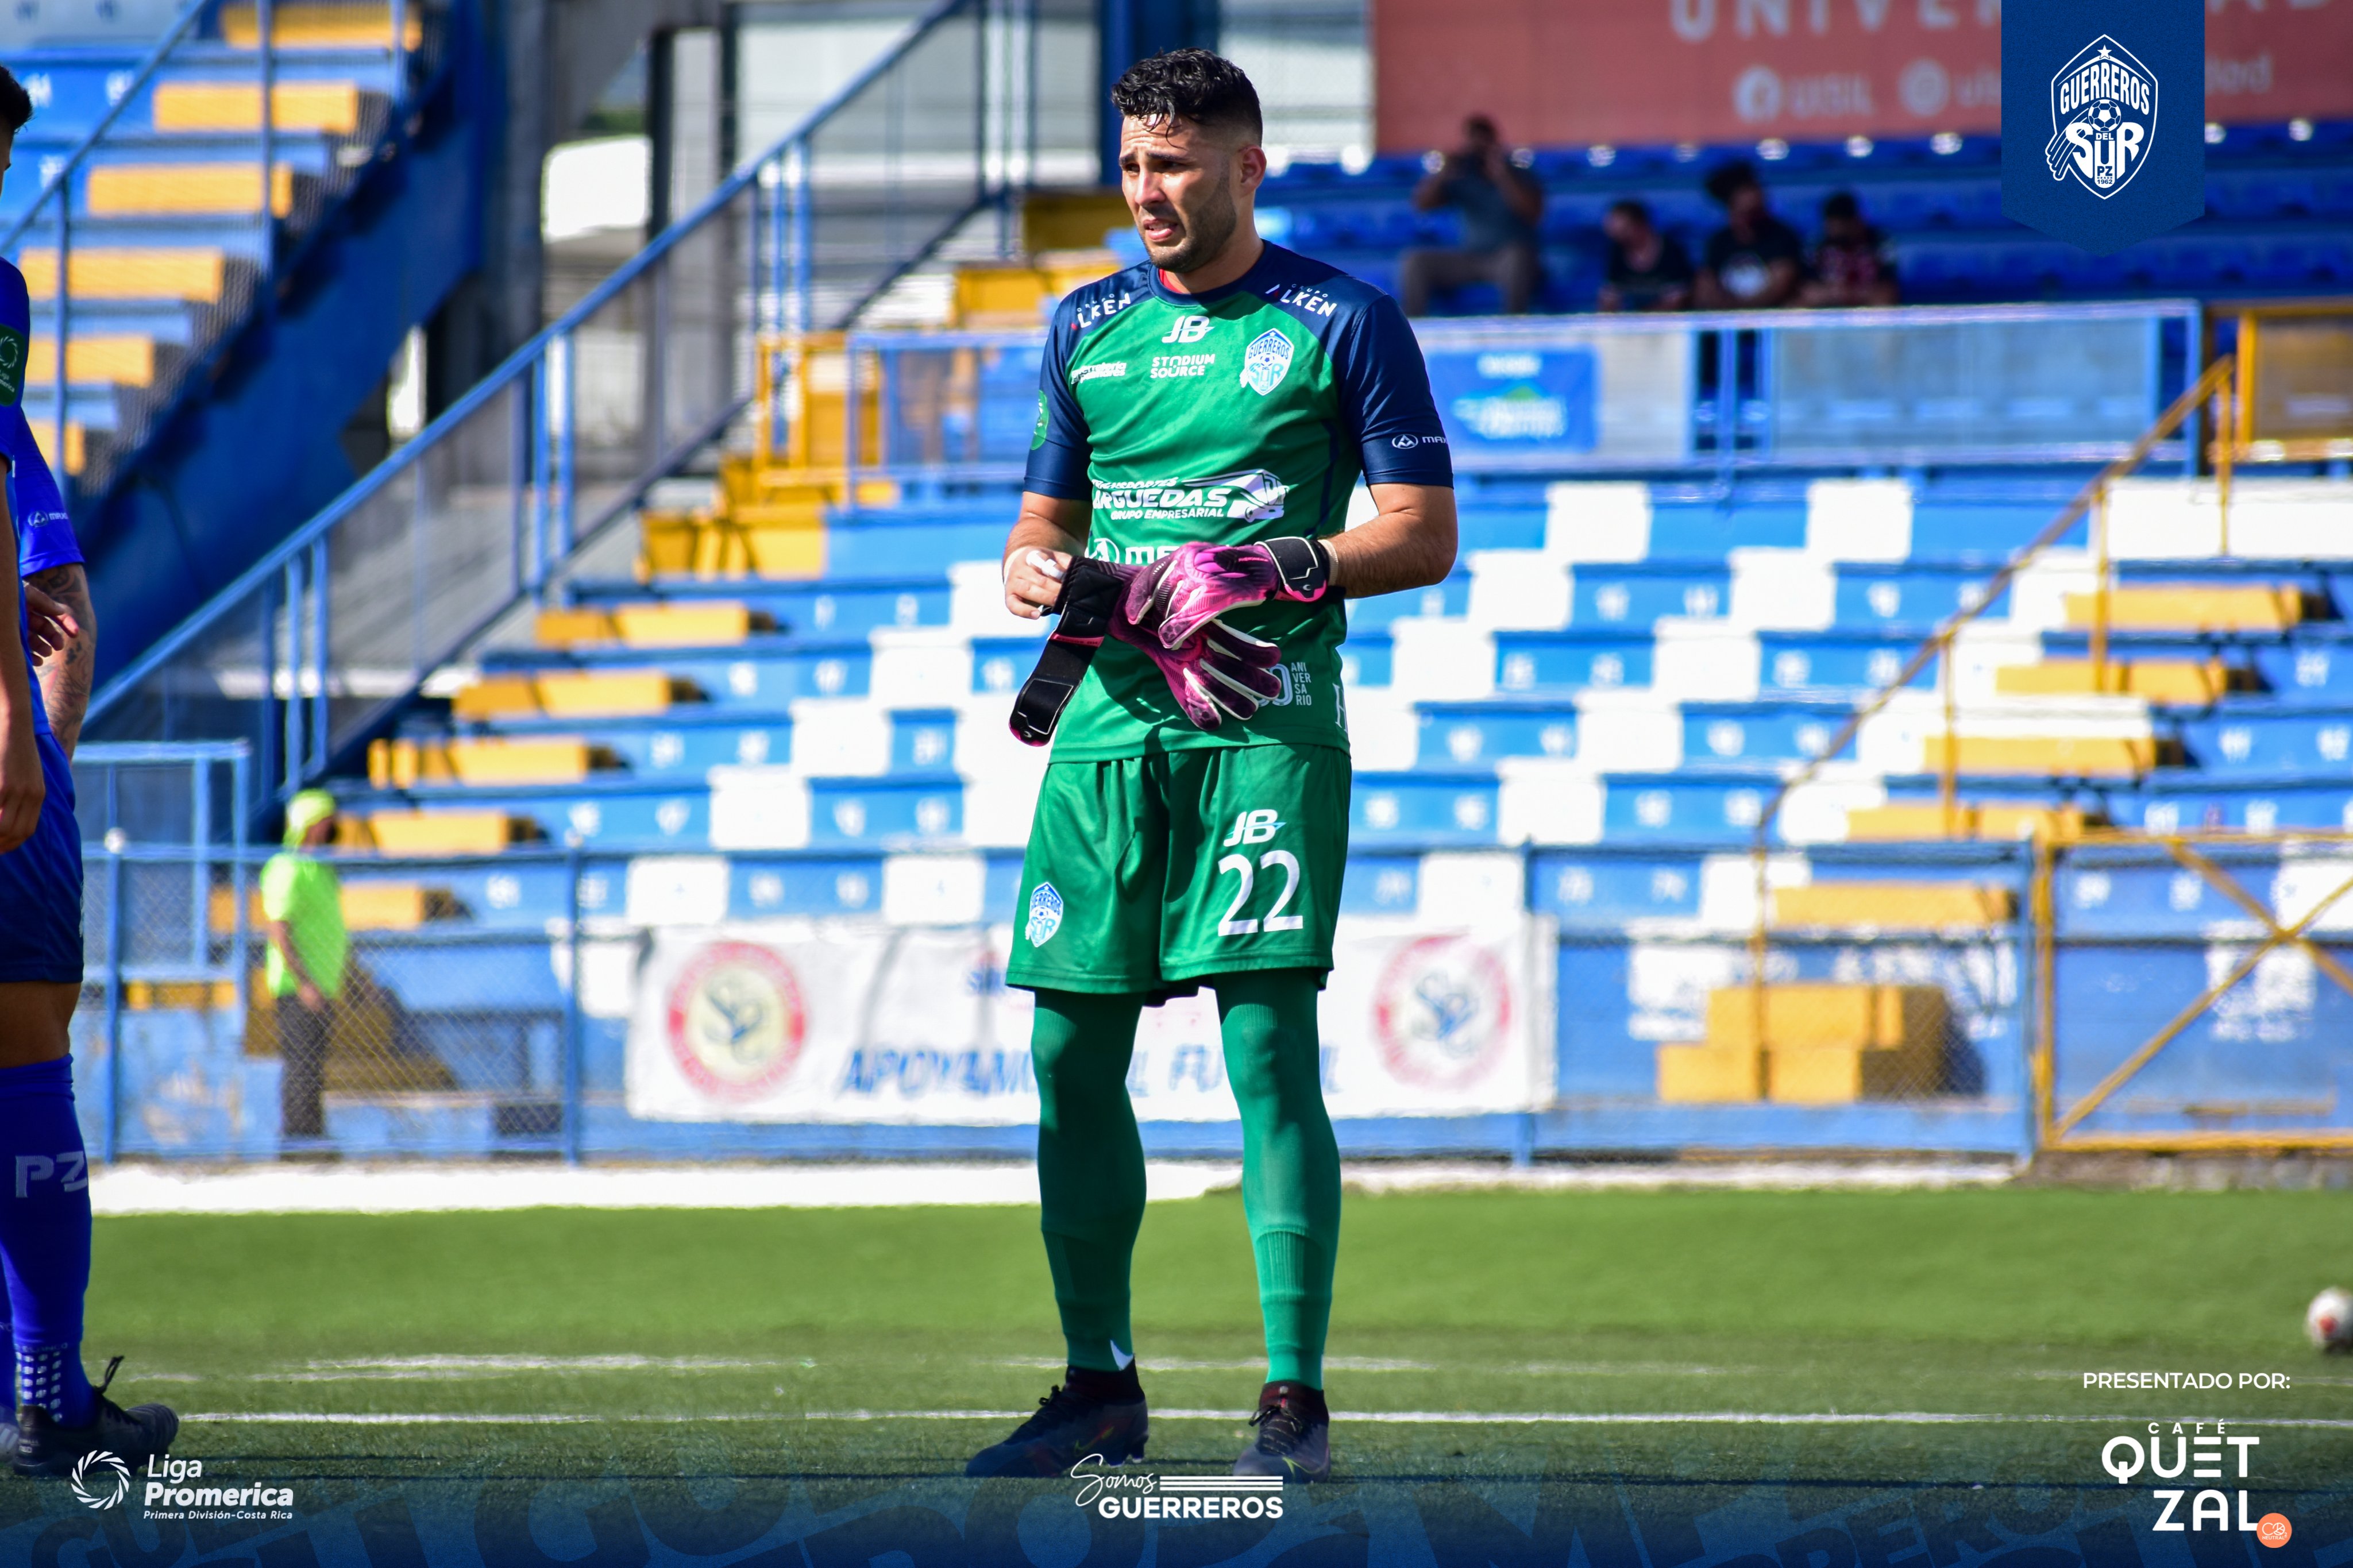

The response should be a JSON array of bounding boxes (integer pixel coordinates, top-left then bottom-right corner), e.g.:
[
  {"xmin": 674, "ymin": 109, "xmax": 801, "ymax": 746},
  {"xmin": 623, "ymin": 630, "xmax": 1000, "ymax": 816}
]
[{"xmin": 628, "ymin": 914, "xmax": 1553, "ymax": 1126}]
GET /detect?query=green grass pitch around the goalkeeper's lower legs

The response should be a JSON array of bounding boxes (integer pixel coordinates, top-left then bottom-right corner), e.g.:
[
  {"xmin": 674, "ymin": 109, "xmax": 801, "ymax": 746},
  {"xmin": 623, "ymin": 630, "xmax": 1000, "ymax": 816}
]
[{"xmin": 68, "ymin": 1187, "xmax": 2353, "ymax": 1486}]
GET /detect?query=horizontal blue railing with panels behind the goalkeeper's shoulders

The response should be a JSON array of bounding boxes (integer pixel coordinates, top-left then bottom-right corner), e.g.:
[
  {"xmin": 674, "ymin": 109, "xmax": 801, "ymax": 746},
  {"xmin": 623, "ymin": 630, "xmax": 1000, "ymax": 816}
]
[{"xmin": 828, "ymin": 301, "xmax": 2205, "ymax": 482}]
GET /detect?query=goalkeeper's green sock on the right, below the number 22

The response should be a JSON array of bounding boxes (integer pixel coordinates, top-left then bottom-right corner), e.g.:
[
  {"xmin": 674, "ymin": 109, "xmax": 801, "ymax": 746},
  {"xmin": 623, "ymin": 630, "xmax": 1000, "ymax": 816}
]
[{"xmin": 1214, "ymin": 968, "xmax": 1339, "ymax": 1389}]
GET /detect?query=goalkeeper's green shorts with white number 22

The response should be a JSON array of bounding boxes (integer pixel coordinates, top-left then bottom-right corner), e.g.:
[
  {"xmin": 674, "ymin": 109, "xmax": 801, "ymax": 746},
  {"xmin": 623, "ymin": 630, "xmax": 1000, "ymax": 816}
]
[{"xmin": 1005, "ymin": 745, "xmax": 1348, "ymax": 994}]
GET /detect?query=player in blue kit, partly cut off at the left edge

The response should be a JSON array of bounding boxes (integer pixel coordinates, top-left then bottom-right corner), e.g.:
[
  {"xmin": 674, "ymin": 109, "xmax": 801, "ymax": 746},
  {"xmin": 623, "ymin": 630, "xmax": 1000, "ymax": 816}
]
[{"xmin": 0, "ymin": 71, "xmax": 179, "ymax": 1476}]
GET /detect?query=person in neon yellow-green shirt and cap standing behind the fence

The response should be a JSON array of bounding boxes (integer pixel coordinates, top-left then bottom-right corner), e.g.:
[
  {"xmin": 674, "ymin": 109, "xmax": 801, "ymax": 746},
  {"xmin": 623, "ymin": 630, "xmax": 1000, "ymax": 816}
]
[{"xmin": 261, "ymin": 790, "xmax": 350, "ymax": 1140}]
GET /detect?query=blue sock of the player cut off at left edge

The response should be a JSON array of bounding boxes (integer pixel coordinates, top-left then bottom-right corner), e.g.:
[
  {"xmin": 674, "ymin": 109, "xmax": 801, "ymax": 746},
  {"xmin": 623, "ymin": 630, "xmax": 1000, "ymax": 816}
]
[{"xmin": 0, "ymin": 1058, "xmax": 97, "ymax": 1427}]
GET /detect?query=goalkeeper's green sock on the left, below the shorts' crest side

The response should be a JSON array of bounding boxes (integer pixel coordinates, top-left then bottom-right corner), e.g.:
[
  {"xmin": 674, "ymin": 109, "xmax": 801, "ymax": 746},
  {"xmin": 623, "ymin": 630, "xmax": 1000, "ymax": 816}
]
[{"xmin": 1031, "ymin": 990, "xmax": 1144, "ymax": 1373}]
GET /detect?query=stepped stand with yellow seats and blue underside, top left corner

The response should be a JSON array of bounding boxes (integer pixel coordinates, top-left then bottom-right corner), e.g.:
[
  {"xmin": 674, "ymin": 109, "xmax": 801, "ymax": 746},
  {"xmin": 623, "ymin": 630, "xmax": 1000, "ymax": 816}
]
[{"xmin": 0, "ymin": 0, "xmax": 485, "ymax": 670}]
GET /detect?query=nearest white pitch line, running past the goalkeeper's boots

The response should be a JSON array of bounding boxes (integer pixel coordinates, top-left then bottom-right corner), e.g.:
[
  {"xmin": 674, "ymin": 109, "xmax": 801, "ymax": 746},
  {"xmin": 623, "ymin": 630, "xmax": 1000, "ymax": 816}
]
[{"xmin": 186, "ymin": 1411, "xmax": 2353, "ymax": 1432}]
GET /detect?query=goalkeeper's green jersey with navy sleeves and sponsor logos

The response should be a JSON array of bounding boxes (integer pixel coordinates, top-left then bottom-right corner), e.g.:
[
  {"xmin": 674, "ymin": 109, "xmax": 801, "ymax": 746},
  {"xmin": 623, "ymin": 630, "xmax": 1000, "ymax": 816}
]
[{"xmin": 1024, "ymin": 245, "xmax": 1454, "ymax": 762}]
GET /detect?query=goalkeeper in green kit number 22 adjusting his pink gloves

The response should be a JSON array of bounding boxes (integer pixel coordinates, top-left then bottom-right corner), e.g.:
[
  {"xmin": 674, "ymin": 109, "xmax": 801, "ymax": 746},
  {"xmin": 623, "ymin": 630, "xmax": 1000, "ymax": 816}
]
[{"xmin": 967, "ymin": 49, "xmax": 1454, "ymax": 1481}]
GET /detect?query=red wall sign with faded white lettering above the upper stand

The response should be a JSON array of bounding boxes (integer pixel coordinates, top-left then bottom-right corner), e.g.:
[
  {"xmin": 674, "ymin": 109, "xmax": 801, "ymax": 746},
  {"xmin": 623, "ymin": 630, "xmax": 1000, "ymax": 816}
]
[{"xmin": 1372, "ymin": 0, "xmax": 2353, "ymax": 150}]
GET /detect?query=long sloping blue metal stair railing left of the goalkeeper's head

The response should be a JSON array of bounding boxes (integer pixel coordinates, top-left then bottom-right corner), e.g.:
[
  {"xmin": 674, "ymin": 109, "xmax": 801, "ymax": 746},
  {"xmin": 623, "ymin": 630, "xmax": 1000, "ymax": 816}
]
[{"xmin": 87, "ymin": 0, "xmax": 1059, "ymax": 827}]
